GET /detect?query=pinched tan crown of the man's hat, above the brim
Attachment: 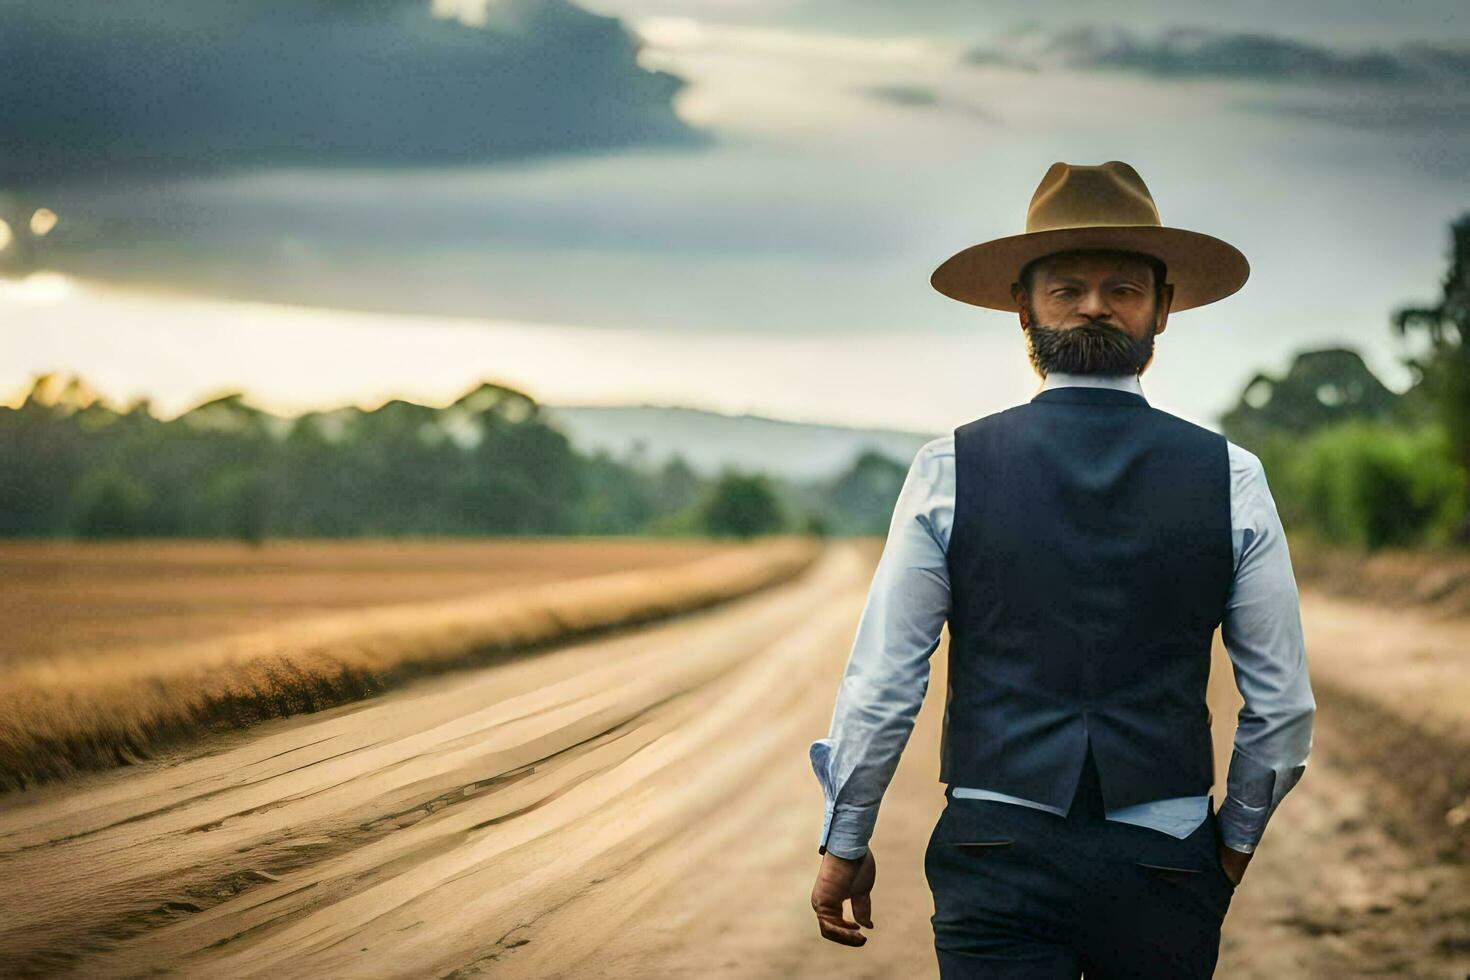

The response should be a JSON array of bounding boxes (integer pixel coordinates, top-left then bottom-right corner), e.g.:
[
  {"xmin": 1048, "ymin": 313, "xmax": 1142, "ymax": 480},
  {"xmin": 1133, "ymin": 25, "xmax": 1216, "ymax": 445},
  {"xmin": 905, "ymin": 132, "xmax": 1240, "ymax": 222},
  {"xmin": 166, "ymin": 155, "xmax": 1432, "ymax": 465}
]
[{"xmin": 1026, "ymin": 160, "xmax": 1161, "ymax": 234}]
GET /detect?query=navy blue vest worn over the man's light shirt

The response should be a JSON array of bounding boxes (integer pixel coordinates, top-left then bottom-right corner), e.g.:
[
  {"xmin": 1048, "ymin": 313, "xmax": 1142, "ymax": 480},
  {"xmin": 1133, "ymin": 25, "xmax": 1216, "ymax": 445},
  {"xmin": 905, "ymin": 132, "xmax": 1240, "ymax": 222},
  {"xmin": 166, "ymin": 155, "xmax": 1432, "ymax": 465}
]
[{"xmin": 939, "ymin": 386, "xmax": 1235, "ymax": 810}]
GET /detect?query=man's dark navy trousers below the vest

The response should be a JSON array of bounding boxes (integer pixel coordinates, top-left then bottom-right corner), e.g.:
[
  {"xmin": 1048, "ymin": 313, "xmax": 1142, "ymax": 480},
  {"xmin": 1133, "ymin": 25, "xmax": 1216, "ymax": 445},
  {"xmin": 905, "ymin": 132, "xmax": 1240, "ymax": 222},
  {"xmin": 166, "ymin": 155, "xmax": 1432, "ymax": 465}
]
[{"xmin": 925, "ymin": 749, "xmax": 1235, "ymax": 980}]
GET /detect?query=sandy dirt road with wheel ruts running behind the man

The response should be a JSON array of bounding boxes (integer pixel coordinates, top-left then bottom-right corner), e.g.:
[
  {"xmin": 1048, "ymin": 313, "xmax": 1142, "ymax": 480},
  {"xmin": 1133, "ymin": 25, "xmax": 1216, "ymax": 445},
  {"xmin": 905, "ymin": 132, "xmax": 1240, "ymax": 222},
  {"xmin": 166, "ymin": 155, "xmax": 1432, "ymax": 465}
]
[{"xmin": 0, "ymin": 544, "xmax": 1470, "ymax": 979}]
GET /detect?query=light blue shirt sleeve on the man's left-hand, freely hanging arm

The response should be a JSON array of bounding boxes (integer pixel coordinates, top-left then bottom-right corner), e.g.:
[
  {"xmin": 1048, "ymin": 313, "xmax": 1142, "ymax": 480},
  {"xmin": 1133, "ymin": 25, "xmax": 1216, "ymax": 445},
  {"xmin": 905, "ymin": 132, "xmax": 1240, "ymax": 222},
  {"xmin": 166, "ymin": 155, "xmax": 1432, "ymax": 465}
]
[{"xmin": 810, "ymin": 436, "xmax": 954, "ymax": 858}]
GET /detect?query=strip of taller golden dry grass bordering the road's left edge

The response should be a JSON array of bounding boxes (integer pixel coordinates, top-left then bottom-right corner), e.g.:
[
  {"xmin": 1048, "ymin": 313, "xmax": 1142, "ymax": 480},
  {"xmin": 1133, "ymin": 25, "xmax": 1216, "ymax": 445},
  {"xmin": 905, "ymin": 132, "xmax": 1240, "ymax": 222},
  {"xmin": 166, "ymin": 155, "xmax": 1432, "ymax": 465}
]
[{"xmin": 0, "ymin": 538, "xmax": 820, "ymax": 790}]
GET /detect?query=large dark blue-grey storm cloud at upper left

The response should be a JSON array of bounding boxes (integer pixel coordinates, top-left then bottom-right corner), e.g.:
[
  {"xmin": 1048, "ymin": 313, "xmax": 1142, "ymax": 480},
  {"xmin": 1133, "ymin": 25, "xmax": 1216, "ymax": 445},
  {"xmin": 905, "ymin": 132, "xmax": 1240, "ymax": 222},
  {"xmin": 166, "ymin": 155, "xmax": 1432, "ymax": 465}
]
[{"xmin": 0, "ymin": 0, "xmax": 697, "ymax": 187}]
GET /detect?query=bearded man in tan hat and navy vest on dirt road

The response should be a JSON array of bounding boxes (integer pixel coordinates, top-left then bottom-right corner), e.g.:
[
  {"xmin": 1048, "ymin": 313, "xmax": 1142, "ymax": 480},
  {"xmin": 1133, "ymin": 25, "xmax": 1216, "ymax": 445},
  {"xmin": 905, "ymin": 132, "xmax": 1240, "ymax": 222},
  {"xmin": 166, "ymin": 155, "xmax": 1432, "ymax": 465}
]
[{"xmin": 811, "ymin": 160, "xmax": 1316, "ymax": 977}]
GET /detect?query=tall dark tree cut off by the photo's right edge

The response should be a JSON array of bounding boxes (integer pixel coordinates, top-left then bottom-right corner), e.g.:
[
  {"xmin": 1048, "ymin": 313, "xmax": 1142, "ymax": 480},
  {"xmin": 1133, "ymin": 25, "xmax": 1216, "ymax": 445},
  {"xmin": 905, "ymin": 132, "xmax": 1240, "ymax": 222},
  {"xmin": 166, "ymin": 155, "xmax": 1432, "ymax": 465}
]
[{"xmin": 1392, "ymin": 212, "xmax": 1470, "ymax": 544}]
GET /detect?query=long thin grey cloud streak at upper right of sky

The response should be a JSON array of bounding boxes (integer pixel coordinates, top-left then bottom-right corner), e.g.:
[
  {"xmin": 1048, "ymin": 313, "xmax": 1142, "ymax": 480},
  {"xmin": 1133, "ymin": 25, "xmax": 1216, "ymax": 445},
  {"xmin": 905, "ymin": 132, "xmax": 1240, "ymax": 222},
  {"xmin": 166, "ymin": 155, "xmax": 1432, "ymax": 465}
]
[{"xmin": 966, "ymin": 25, "xmax": 1470, "ymax": 88}]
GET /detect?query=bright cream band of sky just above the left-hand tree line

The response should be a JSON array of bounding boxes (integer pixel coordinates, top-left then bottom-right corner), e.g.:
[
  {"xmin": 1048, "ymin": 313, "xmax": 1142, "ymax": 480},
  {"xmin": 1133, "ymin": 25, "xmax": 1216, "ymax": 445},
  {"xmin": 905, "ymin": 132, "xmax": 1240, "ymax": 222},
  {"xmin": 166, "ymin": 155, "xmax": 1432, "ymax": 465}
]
[{"xmin": 0, "ymin": 272, "xmax": 993, "ymax": 432}]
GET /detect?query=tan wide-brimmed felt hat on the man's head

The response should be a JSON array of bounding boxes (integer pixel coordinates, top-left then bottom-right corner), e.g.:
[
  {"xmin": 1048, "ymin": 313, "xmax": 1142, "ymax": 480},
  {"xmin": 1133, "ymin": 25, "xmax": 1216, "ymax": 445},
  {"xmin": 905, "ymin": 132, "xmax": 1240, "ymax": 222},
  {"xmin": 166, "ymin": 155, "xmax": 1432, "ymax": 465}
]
[{"xmin": 929, "ymin": 160, "xmax": 1251, "ymax": 313}]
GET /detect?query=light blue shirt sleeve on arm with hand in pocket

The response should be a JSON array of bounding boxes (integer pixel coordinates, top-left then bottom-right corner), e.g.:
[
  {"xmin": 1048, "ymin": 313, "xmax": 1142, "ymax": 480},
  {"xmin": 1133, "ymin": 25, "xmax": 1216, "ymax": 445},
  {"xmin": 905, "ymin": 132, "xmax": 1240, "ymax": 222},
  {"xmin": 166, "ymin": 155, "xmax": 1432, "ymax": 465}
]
[{"xmin": 1217, "ymin": 444, "xmax": 1317, "ymax": 852}]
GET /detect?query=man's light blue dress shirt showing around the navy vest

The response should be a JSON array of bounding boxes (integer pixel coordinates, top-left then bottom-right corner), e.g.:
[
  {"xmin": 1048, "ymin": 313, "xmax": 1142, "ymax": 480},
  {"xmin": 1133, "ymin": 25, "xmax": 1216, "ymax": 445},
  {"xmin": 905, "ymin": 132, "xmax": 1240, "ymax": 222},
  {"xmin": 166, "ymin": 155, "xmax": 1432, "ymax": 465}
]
[{"xmin": 810, "ymin": 372, "xmax": 1316, "ymax": 858}]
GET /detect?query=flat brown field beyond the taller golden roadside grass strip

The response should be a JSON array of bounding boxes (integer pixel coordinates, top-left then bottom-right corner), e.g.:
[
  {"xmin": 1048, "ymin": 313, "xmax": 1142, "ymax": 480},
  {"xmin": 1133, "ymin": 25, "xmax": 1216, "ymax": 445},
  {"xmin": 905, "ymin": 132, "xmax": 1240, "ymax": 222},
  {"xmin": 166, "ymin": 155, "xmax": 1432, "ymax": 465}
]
[{"xmin": 0, "ymin": 538, "xmax": 729, "ymax": 664}]
